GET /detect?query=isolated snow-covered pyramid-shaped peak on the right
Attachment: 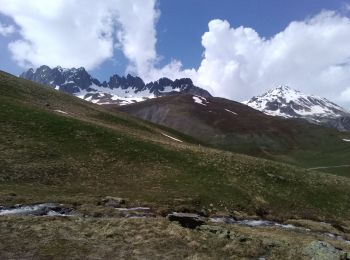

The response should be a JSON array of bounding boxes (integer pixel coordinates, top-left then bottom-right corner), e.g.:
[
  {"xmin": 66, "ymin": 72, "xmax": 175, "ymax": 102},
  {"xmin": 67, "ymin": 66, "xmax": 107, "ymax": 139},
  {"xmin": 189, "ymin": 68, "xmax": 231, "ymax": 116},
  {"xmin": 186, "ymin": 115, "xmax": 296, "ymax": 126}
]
[{"xmin": 243, "ymin": 86, "xmax": 350, "ymax": 131}]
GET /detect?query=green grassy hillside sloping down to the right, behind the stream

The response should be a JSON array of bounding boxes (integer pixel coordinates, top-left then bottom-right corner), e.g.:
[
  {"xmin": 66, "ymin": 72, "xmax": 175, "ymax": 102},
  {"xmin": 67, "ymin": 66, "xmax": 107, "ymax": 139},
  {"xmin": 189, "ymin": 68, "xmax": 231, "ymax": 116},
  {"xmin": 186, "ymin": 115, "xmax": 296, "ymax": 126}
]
[{"xmin": 0, "ymin": 73, "xmax": 350, "ymax": 219}]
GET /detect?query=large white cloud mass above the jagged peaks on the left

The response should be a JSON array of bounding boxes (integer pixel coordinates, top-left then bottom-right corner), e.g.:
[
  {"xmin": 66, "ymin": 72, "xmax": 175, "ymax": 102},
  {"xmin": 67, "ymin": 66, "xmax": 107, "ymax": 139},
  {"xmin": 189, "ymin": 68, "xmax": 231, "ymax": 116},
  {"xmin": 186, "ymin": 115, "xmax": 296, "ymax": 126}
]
[{"xmin": 0, "ymin": 0, "xmax": 158, "ymax": 71}]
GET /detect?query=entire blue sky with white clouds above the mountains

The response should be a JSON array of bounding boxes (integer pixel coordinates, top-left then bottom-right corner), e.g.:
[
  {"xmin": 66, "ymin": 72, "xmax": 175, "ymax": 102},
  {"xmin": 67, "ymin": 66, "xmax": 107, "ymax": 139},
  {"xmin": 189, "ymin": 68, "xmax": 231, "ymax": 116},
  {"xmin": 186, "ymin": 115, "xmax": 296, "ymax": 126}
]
[{"xmin": 0, "ymin": 0, "xmax": 350, "ymax": 109}]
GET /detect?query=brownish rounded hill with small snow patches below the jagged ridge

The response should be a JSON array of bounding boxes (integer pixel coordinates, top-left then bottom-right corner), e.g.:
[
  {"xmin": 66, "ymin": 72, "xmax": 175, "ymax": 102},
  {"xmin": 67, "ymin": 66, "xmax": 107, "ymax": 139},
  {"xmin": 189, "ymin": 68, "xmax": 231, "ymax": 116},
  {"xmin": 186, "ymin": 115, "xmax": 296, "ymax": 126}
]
[{"xmin": 112, "ymin": 95, "xmax": 350, "ymax": 173}]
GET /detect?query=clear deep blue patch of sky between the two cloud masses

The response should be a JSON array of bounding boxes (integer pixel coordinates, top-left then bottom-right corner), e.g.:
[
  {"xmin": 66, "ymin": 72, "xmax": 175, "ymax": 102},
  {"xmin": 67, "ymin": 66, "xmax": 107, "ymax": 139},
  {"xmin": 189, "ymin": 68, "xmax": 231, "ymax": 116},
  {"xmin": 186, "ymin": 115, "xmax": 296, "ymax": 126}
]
[{"xmin": 157, "ymin": 0, "xmax": 346, "ymax": 70}]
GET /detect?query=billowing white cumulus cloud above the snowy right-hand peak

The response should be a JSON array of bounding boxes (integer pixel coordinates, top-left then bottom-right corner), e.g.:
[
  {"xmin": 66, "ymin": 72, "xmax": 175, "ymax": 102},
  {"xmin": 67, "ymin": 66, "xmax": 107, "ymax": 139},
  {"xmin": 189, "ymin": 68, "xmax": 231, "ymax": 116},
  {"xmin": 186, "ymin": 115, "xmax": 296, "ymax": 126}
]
[{"xmin": 152, "ymin": 11, "xmax": 350, "ymax": 107}]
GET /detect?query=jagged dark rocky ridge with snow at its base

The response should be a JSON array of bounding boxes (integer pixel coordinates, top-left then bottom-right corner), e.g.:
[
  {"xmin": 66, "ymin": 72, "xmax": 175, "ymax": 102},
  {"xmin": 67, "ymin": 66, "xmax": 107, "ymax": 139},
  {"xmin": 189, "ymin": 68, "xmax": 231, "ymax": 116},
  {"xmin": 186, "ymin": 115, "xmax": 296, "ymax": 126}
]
[{"xmin": 20, "ymin": 65, "xmax": 211, "ymax": 105}]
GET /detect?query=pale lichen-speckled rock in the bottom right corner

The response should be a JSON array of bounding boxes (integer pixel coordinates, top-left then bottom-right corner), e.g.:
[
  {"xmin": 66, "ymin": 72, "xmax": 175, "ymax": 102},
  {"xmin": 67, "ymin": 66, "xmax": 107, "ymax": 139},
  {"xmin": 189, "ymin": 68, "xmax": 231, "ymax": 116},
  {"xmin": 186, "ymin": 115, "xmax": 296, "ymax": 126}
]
[{"xmin": 302, "ymin": 241, "xmax": 347, "ymax": 260}]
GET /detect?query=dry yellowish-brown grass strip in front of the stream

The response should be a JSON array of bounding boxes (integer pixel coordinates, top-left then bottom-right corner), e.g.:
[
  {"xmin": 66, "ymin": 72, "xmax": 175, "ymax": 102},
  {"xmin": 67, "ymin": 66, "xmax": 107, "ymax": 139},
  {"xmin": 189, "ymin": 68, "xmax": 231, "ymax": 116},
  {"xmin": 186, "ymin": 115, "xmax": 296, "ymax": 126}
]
[{"xmin": 0, "ymin": 217, "xmax": 350, "ymax": 259}]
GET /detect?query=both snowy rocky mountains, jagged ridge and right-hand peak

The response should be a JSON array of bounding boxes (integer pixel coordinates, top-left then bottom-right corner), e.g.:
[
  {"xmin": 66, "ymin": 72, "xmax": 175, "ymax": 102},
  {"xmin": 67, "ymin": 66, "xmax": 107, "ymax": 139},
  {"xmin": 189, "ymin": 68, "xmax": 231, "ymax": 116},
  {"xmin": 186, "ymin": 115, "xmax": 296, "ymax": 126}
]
[{"xmin": 20, "ymin": 65, "xmax": 350, "ymax": 131}]
